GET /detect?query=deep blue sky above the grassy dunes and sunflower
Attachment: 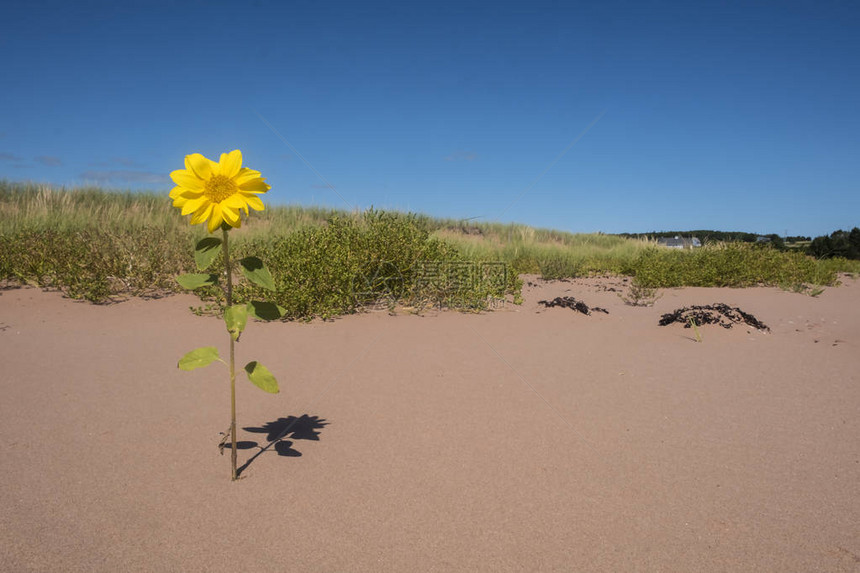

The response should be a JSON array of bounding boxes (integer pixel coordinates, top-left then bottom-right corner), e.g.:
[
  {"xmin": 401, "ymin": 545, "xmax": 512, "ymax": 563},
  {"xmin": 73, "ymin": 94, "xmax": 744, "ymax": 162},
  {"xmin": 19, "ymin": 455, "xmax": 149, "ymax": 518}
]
[{"xmin": 0, "ymin": 0, "xmax": 860, "ymax": 235}]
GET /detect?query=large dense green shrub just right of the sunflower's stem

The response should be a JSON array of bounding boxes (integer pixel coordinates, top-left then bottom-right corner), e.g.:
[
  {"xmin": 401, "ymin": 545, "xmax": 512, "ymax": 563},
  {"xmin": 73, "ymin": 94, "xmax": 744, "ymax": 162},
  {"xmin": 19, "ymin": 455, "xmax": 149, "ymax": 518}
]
[{"xmin": 234, "ymin": 211, "xmax": 513, "ymax": 318}]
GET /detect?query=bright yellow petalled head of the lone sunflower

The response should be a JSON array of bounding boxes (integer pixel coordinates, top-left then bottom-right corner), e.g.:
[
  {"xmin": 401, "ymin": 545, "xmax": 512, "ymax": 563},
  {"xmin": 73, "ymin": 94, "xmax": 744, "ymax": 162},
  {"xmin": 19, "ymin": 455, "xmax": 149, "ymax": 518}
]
[{"xmin": 170, "ymin": 149, "xmax": 272, "ymax": 233}]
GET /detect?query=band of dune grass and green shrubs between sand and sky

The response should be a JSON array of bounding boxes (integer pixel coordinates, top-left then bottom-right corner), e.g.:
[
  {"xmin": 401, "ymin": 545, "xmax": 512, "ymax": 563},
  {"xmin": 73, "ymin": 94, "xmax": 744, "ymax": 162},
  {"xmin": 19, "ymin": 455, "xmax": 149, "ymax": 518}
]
[{"xmin": 0, "ymin": 181, "xmax": 860, "ymax": 318}]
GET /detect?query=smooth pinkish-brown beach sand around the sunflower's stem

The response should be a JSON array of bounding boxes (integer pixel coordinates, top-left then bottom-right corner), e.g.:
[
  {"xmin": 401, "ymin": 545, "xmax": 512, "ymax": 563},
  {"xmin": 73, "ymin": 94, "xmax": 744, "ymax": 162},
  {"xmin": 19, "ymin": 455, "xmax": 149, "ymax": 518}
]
[{"xmin": 0, "ymin": 278, "xmax": 860, "ymax": 572}]
